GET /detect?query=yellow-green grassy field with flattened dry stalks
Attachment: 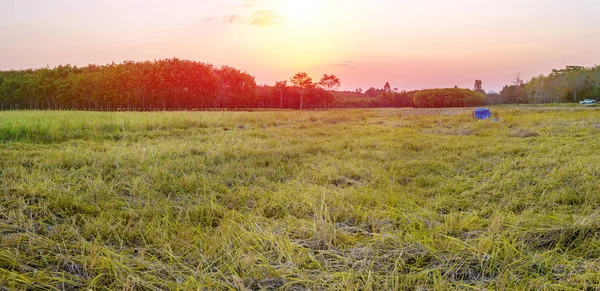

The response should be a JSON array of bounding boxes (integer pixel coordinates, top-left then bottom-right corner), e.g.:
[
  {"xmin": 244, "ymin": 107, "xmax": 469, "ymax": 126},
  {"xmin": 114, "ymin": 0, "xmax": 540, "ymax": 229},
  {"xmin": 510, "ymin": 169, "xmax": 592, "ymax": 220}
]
[{"xmin": 0, "ymin": 107, "xmax": 600, "ymax": 291}]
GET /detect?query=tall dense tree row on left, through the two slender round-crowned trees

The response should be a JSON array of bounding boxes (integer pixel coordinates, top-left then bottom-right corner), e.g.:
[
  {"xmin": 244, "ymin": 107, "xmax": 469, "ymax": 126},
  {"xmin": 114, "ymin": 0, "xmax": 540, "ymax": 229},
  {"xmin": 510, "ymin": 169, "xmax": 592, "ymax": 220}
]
[{"xmin": 0, "ymin": 59, "xmax": 341, "ymax": 110}]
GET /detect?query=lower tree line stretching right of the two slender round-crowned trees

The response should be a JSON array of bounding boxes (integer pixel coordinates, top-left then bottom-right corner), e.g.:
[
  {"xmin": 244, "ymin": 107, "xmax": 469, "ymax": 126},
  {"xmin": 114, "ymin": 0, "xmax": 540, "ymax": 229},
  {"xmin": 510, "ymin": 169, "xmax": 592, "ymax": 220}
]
[{"xmin": 344, "ymin": 66, "xmax": 600, "ymax": 107}]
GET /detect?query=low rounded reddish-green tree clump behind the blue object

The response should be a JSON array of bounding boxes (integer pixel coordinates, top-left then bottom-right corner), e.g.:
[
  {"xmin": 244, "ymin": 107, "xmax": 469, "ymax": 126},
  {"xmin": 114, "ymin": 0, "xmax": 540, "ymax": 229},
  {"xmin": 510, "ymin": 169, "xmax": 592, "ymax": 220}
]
[{"xmin": 413, "ymin": 88, "xmax": 485, "ymax": 108}]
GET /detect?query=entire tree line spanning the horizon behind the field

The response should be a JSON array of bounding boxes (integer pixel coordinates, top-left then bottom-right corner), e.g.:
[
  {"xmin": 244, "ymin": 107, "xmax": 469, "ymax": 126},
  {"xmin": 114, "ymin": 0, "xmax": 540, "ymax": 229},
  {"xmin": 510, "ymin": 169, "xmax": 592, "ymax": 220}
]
[{"xmin": 0, "ymin": 58, "xmax": 600, "ymax": 111}]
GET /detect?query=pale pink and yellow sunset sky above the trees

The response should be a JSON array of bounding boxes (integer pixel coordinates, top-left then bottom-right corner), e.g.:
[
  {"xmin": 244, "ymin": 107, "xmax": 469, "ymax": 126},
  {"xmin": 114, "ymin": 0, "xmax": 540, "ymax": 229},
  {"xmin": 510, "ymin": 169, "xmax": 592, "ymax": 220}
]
[{"xmin": 0, "ymin": 0, "xmax": 600, "ymax": 91}]
